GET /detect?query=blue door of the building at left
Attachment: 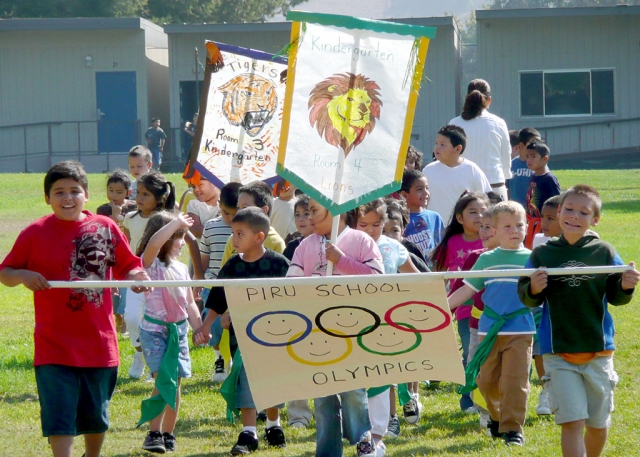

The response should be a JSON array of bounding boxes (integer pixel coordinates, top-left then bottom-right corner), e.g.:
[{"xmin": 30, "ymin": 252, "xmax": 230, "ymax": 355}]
[{"xmin": 96, "ymin": 71, "xmax": 140, "ymax": 152}]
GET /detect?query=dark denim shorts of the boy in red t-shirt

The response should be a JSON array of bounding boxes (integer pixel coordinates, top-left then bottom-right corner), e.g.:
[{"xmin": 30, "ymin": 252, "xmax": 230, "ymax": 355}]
[{"xmin": 35, "ymin": 365, "xmax": 118, "ymax": 436}]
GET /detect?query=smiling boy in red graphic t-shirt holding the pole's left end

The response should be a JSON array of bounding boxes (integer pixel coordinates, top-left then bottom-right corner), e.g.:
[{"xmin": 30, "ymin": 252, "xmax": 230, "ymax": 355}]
[{"xmin": 0, "ymin": 161, "xmax": 149, "ymax": 457}]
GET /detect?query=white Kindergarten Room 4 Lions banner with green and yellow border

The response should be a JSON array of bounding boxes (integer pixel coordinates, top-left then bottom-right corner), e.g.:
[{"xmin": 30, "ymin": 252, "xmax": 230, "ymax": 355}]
[{"xmin": 278, "ymin": 11, "xmax": 436, "ymax": 215}]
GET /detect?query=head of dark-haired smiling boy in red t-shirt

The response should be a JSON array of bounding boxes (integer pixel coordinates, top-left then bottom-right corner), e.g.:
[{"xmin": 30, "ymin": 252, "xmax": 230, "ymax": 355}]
[{"xmin": 44, "ymin": 160, "xmax": 89, "ymax": 221}]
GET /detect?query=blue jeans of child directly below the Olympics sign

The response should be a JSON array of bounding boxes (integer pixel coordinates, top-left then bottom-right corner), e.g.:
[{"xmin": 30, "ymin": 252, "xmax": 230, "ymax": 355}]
[{"xmin": 313, "ymin": 389, "xmax": 371, "ymax": 457}]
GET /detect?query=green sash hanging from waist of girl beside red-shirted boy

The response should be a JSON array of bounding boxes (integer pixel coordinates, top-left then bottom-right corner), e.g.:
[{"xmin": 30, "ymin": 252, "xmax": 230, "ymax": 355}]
[{"xmin": 136, "ymin": 314, "xmax": 185, "ymax": 427}]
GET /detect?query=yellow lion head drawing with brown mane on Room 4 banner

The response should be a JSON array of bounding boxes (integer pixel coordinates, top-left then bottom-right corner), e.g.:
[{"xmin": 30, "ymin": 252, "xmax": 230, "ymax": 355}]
[{"xmin": 308, "ymin": 73, "xmax": 382, "ymax": 156}]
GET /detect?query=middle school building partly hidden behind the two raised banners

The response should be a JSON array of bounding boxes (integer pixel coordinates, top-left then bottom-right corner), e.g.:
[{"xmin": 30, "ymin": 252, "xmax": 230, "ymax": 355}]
[{"xmin": 164, "ymin": 16, "xmax": 462, "ymax": 164}]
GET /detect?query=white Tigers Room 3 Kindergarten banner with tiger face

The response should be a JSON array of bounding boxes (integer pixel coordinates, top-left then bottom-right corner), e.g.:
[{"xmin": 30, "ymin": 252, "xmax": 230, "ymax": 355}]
[{"xmin": 191, "ymin": 42, "xmax": 287, "ymax": 187}]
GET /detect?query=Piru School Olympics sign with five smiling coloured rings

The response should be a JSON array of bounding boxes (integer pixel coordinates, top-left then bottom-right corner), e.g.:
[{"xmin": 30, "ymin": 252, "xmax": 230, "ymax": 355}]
[{"xmin": 225, "ymin": 275, "xmax": 464, "ymax": 410}]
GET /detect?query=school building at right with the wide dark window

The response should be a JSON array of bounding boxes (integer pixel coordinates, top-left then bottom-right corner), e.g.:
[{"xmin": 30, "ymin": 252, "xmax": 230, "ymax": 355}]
[{"xmin": 476, "ymin": 6, "xmax": 640, "ymax": 160}]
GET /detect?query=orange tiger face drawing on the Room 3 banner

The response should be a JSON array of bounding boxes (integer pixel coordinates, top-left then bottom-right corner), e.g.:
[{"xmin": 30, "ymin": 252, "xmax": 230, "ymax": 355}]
[{"xmin": 219, "ymin": 73, "xmax": 278, "ymax": 137}]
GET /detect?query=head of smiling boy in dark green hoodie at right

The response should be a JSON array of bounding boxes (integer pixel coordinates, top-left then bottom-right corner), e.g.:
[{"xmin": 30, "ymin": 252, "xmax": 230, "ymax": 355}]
[{"xmin": 558, "ymin": 184, "xmax": 602, "ymax": 241}]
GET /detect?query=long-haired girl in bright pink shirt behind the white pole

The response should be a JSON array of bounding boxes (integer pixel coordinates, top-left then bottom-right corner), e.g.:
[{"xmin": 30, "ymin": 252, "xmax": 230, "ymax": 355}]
[{"xmin": 431, "ymin": 192, "xmax": 489, "ymax": 413}]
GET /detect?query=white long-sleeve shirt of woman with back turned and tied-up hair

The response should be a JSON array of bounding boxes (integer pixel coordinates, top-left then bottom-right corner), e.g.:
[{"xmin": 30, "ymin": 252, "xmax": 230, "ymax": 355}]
[{"xmin": 449, "ymin": 109, "xmax": 511, "ymax": 184}]
